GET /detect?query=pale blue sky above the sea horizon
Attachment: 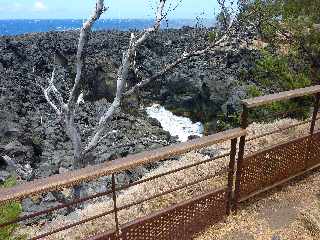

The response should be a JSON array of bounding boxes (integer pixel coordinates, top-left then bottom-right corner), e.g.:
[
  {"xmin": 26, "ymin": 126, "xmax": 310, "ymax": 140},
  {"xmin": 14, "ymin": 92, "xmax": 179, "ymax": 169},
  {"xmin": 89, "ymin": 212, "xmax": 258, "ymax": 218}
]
[{"xmin": 0, "ymin": 0, "xmax": 218, "ymax": 19}]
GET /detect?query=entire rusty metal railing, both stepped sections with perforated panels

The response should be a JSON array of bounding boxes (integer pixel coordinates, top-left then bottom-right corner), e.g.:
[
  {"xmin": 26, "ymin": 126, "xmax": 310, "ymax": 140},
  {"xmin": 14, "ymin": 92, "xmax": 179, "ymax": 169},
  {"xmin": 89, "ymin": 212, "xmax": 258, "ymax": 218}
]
[{"xmin": 0, "ymin": 86, "xmax": 320, "ymax": 240}]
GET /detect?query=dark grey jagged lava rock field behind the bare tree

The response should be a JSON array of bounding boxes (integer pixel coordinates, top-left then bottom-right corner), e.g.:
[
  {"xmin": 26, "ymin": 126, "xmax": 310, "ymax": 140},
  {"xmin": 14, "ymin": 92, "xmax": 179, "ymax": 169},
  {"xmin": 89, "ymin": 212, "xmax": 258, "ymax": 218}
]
[{"xmin": 0, "ymin": 28, "xmax": 255, "ymax": 184}]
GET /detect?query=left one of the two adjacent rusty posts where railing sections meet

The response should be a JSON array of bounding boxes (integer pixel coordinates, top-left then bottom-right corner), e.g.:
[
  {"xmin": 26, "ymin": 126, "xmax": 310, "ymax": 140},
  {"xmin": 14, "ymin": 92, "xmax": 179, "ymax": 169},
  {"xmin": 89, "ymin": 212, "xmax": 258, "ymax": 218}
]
[{"xmin": 227, "ymin": 138, "xmax": 238, "ymax": 215}]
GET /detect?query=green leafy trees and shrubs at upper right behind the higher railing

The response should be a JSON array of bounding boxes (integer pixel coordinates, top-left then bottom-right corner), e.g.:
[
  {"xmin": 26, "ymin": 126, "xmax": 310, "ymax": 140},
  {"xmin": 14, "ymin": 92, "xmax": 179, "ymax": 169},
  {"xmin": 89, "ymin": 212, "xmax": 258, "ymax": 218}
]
[{"xmin": 236, "ymin": 0, "xmax": 320, "ymax": 123}]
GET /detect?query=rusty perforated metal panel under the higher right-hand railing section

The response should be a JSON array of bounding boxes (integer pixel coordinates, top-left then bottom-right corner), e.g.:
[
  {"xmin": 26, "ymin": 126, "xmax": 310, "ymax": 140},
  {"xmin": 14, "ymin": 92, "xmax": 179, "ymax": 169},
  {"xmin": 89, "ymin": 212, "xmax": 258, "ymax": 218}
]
[{"xmin": 236, "ymin": 133, "xmax": 320, "ymax": 200}]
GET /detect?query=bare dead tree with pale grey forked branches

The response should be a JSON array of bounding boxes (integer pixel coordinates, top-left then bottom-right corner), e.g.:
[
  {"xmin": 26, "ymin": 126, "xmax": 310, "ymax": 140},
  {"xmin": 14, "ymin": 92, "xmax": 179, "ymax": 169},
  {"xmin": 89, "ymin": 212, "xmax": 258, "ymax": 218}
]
[{"xmin": 38, "ymin": 0, "xmax": 236, "ymax": 176}]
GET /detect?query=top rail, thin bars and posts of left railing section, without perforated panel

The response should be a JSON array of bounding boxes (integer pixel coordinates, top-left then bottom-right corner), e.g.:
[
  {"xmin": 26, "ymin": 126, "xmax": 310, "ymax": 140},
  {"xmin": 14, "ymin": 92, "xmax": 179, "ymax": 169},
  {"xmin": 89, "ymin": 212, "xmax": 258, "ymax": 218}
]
[{"xmin": 0, "ymin": 129, "xmax": 246, "ymax": 239}]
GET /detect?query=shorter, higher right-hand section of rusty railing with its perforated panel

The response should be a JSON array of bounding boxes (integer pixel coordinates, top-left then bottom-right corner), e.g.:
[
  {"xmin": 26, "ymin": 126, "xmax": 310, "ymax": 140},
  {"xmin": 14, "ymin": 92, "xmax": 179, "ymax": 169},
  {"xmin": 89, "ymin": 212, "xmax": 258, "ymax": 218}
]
[{"xmin": 234, "ymin": 85, "xmax": 320, "ymax": 209}]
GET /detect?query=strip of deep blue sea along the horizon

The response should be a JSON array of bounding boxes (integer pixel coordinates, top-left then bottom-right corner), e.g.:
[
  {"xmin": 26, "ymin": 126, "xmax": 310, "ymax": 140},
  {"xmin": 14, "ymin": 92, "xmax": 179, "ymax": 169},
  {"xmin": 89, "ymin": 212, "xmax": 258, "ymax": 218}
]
[{"xmin": 0, "ymin": 19, "xmax": 214, "ymax": 36}]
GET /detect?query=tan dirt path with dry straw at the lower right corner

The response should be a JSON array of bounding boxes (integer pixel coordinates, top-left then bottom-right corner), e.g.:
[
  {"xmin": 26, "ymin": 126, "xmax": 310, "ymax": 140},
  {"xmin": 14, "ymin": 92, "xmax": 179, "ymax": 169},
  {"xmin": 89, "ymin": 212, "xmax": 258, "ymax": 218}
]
[{"xmin": 196, "ymin": 171, "xmax": 320, "ymax": 240}]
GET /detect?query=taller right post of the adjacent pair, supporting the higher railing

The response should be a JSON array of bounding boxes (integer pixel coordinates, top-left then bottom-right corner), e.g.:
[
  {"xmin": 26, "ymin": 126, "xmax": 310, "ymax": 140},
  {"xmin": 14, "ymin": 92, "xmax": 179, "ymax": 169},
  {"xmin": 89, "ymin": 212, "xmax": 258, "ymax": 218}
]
[{"xmin": 234, "ymin": 104, "xmax": 249, "ymax": 211}]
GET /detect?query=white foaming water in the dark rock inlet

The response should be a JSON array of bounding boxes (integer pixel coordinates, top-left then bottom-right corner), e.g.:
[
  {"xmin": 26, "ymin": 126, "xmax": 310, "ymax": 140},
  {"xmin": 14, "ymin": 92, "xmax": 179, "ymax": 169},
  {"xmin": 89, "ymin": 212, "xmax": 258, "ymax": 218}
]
[{"xmin": 146, "ymin": 104, "xmax": 203, "ymax": 142}]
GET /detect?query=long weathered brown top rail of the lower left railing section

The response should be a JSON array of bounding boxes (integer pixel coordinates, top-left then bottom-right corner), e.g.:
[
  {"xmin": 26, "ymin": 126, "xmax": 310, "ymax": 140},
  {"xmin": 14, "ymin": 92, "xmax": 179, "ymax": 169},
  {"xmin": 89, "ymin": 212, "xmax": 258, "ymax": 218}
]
[{"xmin": 0, "ymin": 128, "xmax": 246, "ymax": 204}]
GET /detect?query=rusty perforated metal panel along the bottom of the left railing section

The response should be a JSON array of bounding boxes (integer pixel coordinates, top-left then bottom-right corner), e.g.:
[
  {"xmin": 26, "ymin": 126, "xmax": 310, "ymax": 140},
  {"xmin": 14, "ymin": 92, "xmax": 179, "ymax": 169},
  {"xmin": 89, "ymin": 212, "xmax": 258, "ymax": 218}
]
[{"xmin": 94, "ymin": 189, "xmax": 227, "ymax": 240}]
